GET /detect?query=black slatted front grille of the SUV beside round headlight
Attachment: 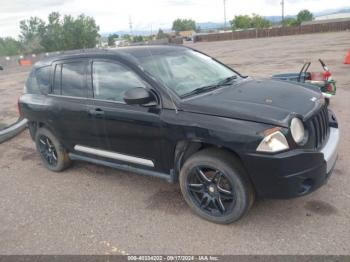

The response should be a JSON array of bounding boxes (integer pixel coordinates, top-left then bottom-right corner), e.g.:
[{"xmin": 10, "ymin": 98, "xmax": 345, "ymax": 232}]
[{"xmin": 307, "ymin": 106, "xmax": 330, "ymax": 149}]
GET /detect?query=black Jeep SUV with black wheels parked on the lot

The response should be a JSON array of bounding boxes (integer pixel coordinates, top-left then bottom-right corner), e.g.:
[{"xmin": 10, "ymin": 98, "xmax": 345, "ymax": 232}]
[{"xmin": 19, "ymin": 46, "xmax": 339, "ymax": 223}]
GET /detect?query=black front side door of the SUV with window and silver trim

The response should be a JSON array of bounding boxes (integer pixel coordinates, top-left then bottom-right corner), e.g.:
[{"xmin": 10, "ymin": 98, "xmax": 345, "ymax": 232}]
[{"xmin": 82, "ymin": 60, "xmax": 162, "ymax": 170}]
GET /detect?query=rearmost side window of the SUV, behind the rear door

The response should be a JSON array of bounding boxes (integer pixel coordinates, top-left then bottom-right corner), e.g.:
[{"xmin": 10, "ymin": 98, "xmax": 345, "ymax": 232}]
[{"xmin": 26, "ymin": 66, "xmax": 51, "ymax": 95}]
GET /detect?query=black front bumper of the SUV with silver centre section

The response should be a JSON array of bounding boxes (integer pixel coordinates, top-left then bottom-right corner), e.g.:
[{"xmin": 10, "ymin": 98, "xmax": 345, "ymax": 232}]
[{"xmin": 241, "ymin": 127, "xmax": 340, "ymax": 198}]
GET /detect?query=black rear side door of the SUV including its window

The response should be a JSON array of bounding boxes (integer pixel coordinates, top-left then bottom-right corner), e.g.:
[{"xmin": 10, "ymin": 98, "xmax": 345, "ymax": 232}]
[{"xmin": 48, "ymin": 59, "xmax": 99, "ymax": 151}]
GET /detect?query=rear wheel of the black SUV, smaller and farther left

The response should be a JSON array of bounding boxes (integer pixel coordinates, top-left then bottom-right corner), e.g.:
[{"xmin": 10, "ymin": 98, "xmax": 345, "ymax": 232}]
[{"xmin": 35, "ymin": 128, "xmax": 71, "ymax": 172}]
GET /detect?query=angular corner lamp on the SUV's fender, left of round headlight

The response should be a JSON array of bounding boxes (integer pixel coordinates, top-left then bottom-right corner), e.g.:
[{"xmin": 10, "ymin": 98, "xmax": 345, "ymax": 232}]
[{"xmin": 256, "ymin": 131, "xmax": 289, "ymax": 153}]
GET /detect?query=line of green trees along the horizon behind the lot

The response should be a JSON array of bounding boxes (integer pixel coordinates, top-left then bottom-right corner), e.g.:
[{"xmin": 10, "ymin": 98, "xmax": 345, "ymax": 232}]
[{"xmin": 0, "ymin": 10, "xmax": 314, "ymax": 56}]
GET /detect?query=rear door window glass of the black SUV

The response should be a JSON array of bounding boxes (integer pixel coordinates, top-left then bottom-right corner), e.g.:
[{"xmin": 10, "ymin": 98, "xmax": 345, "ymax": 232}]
[{"xmin": 60, "ymin": 62, "xmax": 87, "ymax": 97}]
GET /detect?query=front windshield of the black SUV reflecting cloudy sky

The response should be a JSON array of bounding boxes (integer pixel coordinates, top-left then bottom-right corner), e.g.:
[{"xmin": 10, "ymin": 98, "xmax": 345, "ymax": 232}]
[{"xmin": 140, "ymin": 49, "xmax": 237, "ymax": 97}]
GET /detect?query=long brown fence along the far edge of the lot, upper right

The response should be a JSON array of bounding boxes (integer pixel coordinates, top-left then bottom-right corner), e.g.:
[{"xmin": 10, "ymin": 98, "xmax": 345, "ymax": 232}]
[{"xmin": 193, "ymin": 20, "xmax": 350, "ymax": 42}]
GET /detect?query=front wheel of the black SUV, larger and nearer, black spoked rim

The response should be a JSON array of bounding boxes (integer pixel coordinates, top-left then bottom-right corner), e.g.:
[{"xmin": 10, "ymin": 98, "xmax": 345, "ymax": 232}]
[{"xmin": 179, "ymin": 148, "xmax": 255, "ymax": 224}]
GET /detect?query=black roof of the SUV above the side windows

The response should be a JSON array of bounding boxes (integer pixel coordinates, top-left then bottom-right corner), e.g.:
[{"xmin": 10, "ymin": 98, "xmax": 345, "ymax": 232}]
[{"xmin": 35, "ymin": 45, "xmax": 188, "ymax": 67}]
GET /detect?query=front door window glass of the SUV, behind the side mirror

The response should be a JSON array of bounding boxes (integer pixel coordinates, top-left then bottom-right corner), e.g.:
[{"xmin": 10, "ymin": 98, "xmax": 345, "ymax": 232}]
[{"xmin": 92, "ymin": 61, "xmax": 145, "ymax": 102}]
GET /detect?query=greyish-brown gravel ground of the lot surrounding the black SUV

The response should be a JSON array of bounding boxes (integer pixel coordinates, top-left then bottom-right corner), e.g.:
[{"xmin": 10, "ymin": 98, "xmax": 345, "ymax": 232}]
[{"xmin": 0, "ymin": 32, "xmax": 350, "ymax": 254}]
